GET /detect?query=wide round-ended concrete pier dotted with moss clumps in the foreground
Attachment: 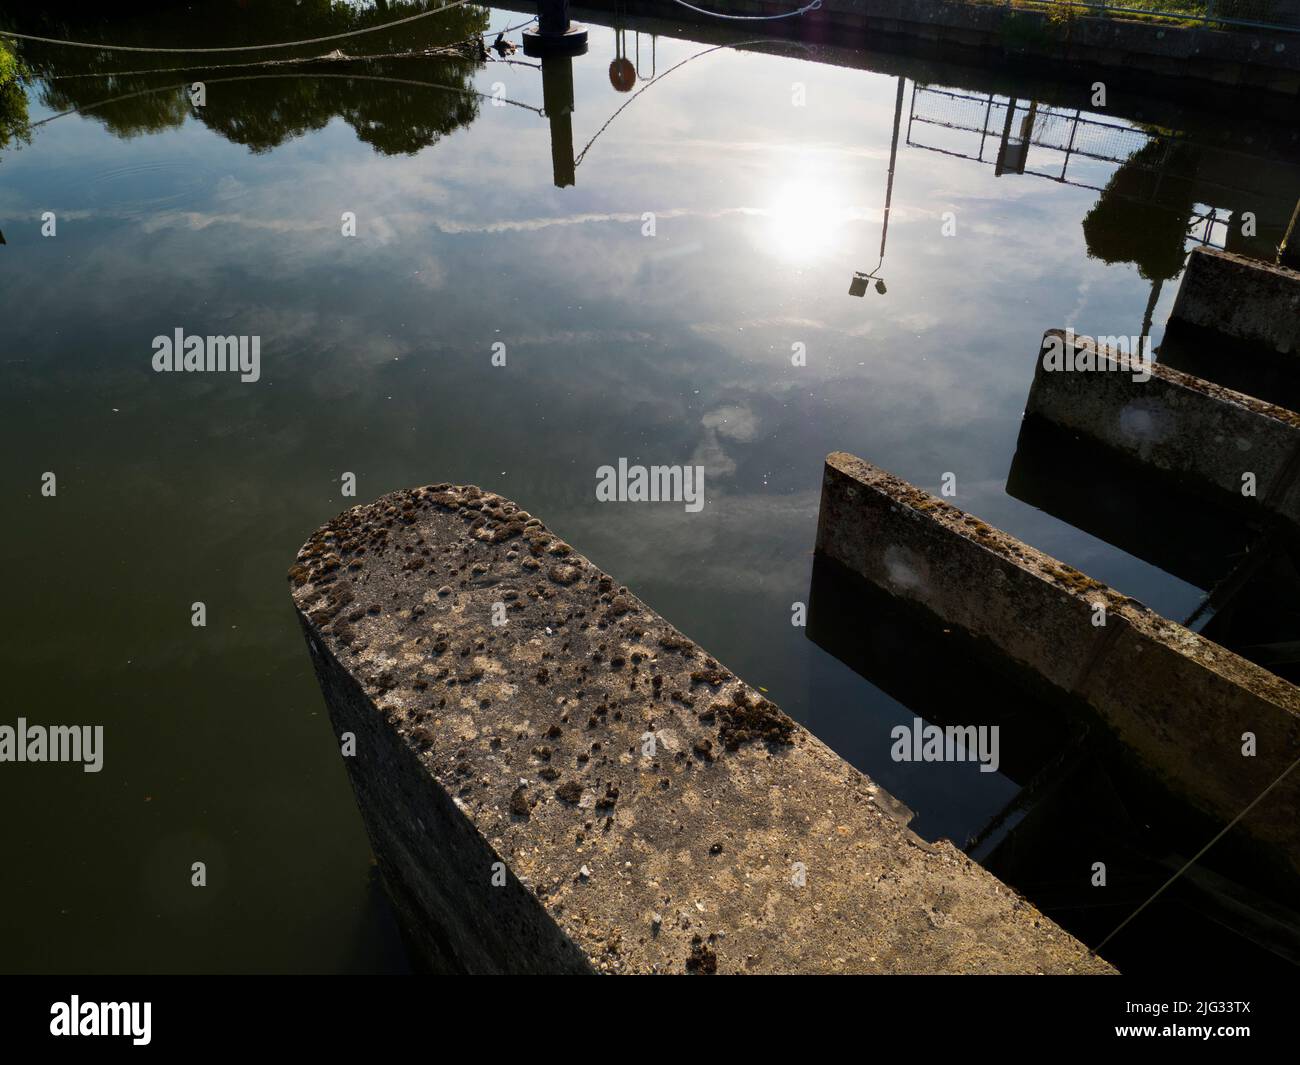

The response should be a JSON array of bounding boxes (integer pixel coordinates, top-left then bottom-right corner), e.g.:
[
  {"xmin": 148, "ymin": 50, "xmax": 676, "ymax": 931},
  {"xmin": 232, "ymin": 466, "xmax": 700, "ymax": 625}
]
[{"xmin": 290, "ymin": 485, "xmax": 1113, "ymax": 973}]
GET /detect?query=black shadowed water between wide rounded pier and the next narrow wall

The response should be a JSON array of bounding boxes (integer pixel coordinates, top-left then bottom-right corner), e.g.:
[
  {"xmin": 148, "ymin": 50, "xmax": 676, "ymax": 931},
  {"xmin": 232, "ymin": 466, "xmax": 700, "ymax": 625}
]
[{"xmin": 807, "ymin": 555, "xmax": 1300, "ymax": 975}]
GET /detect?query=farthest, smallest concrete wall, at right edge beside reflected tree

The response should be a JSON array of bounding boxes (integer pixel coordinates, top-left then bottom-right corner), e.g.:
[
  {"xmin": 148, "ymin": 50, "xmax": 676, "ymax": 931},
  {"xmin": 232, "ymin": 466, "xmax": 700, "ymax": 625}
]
[{"xmin": 1169, "ymin": 248, "xmax": 1300, "ymax": 353}]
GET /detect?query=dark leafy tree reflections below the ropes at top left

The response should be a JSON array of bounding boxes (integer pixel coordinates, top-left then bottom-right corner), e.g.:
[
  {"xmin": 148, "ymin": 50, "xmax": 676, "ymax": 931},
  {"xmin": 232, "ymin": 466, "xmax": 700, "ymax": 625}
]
[{"xmin": 0, "ymin": 0, "xmax": 490, "ymax": 155}]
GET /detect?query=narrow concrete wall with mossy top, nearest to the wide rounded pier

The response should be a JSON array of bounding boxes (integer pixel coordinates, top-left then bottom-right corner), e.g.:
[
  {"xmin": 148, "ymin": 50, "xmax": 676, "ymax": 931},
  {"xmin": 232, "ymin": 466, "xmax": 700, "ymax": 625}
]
[{"xmin": 818, "ymin": 455, "xmax": 1300, "ymax": 876}]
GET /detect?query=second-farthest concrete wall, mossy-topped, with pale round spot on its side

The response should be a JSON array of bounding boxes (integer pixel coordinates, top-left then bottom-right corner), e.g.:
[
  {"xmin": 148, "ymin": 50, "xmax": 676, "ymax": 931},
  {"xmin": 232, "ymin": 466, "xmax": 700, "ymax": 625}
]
[{"xmin": 1024, "ymin": 329, "xmax": 1300, "ymax": 521}]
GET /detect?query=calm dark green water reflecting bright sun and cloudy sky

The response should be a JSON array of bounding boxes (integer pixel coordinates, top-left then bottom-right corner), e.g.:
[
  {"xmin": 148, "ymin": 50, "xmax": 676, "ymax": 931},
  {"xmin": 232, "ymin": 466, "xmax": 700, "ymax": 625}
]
[{"xmin": 0, "ymin": 0, "xmax": 1296, "ymax": 971}]
